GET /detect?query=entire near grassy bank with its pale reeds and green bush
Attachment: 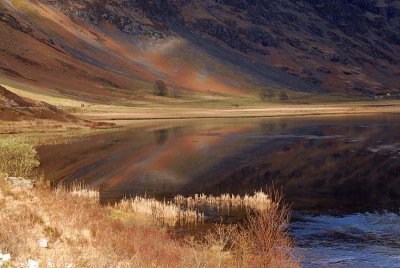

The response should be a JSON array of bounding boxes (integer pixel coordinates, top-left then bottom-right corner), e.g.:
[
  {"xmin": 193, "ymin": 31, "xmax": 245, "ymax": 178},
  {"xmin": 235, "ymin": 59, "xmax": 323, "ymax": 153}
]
[{"xmin": 0, "ymin": 138, "xmax": 299, "ymax": 267}]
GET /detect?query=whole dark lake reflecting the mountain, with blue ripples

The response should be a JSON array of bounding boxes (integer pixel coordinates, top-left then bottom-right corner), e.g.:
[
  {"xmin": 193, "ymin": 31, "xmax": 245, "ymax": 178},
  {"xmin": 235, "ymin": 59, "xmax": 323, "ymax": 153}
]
[{"xmin": 39, "ymin": 115, "xmax": 400, "ymax": 267}]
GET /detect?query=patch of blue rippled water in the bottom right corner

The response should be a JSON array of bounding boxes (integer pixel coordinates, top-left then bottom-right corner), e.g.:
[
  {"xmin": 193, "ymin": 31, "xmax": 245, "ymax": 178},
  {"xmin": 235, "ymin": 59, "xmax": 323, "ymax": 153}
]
[{"xmin": 291, "ymin": 212, "xmax": 400, "ymax": 267}]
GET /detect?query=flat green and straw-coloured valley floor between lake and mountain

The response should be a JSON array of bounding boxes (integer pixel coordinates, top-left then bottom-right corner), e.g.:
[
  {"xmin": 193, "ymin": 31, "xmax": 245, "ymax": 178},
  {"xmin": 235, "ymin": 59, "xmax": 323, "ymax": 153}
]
[{"xmin": 0, "ymin": 81, "xmax": 400, "ymax": 134}]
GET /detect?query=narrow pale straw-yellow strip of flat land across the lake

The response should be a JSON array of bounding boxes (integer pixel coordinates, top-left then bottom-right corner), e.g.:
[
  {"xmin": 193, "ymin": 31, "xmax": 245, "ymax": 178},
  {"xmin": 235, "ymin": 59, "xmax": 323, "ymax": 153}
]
[{"xmin": 74, "ymin": 101, "xmax": 400, "ymax": 121}]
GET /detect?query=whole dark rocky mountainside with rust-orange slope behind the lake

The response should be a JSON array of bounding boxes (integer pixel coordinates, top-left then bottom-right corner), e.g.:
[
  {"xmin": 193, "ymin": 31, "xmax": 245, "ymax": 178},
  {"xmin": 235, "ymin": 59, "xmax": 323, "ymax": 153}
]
[{"xmin": 0, "ymin": 0, "xmax": 400, "ymax": 103}]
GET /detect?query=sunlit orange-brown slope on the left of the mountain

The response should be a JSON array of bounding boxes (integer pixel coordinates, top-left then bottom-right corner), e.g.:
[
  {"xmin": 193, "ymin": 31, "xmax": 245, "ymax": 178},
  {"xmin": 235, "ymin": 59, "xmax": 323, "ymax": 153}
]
[{"xmin": 0, "ymin": 0, "xmax": 322, "ymax": 105}]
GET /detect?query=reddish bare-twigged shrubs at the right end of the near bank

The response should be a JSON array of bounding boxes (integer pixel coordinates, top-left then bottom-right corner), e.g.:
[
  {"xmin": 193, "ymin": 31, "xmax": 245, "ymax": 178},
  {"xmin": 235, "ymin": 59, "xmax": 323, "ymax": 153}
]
[{"xmin": 188, "ymin": 191, "xmax": 300, "ymax": 267}]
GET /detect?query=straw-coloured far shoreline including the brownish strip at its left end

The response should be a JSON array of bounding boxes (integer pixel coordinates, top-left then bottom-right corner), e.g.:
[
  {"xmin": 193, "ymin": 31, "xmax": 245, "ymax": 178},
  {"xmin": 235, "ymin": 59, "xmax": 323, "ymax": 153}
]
[{"xmin": 0, "ymin": 101, "xmax": 400, "ymax": 134}]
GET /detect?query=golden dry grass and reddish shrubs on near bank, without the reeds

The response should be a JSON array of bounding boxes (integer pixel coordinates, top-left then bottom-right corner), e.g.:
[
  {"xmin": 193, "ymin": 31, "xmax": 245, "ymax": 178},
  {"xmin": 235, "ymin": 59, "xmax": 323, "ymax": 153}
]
[{"xmin": 0, "ymin": 179, "xmax": 299, "ymax": 267}]
